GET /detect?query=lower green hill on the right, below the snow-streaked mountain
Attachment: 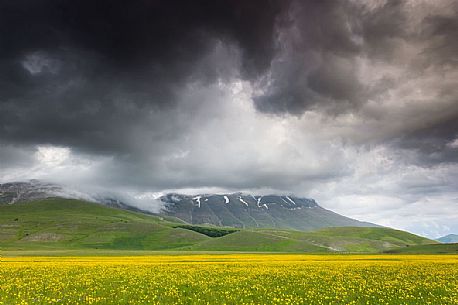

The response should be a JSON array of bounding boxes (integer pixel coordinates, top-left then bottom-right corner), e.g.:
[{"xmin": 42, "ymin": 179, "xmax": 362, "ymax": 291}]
[{"xmin": 183, "ymin": 227, "xmax": 436, "ymax": 253}]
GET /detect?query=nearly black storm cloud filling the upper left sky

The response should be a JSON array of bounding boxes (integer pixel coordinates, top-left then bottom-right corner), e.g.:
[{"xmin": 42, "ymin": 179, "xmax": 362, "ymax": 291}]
[{"xmin": 0, "ymin": 0, "xmax": 287, "ymax": 152}]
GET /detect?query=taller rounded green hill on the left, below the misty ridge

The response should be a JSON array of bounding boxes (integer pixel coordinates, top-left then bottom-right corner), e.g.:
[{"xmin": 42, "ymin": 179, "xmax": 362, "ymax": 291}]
[{"xmin": 0, "ymin": 198, "xmax": 210, "ymax": 250}]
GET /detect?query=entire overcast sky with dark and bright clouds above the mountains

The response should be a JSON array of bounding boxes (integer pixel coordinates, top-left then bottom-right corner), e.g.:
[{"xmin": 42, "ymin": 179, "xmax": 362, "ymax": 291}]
[{"xmin": 0, "ymin": 0, "xmax": 458, "ymax": 237}]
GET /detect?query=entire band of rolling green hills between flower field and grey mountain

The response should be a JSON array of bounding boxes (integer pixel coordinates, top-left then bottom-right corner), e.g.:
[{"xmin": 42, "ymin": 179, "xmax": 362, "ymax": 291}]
[{"xmin": 0, "ymin": 198, "xmax": 435, "ymax": 253}]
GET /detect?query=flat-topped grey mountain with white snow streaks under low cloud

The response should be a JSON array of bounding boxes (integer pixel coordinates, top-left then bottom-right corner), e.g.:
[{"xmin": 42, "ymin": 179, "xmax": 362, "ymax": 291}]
[{"xmin": 160, "ymin": 193, "xmax": 377, "ymax": 231}]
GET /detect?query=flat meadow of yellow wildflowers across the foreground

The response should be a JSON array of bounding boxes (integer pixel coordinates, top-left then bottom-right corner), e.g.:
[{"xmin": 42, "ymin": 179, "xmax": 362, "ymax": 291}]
[{"xmin": 0, "ymin": 254, "xmax": 458, "ymax": 305}]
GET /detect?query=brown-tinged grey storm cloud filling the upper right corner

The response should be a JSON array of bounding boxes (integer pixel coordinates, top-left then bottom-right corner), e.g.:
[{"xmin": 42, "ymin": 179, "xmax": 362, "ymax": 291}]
[{"xmin": 250, "ymin": 0, "xmax": 458, "ymax": 164}]
